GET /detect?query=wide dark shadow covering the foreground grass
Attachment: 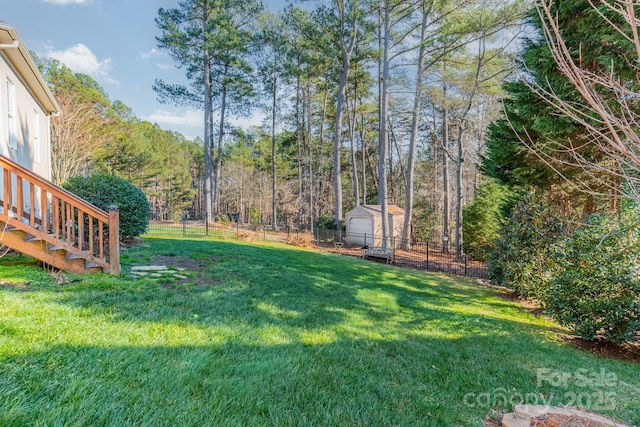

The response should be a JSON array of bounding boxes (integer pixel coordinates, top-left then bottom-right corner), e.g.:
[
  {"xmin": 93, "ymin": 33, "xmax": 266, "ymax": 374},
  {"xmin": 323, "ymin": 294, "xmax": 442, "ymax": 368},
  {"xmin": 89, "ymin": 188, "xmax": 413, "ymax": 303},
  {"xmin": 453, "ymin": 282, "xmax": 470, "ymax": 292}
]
[{"xmin": 0, "ymin": 337, "xmax": 640, "ymax": 426}]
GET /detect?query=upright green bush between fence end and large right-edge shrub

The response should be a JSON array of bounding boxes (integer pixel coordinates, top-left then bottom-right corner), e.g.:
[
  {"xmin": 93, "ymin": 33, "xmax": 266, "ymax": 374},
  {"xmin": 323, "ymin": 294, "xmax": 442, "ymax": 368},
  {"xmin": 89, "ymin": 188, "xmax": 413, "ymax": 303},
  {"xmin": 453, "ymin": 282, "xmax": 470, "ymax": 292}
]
[{"xmin": 487, "ymin": 195, "xmax": 564, "ymax": 298}]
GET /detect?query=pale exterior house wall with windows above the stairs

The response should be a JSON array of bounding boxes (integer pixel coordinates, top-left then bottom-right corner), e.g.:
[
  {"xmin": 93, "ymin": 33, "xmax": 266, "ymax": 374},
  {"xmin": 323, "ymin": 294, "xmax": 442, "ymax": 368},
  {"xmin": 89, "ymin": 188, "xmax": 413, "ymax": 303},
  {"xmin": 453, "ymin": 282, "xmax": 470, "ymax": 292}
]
[{"xmin": 0, "ymin": 50, "xmax": 51, "ymax": 180}]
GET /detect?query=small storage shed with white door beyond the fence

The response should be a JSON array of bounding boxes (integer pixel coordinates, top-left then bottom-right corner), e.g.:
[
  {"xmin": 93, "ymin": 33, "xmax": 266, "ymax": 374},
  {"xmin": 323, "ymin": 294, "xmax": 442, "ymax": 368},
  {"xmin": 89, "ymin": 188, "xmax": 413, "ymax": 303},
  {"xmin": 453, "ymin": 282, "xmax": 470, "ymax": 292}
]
[{"xmin": 346, "ymin": 205, "xmax": 404, "ymax": 246}]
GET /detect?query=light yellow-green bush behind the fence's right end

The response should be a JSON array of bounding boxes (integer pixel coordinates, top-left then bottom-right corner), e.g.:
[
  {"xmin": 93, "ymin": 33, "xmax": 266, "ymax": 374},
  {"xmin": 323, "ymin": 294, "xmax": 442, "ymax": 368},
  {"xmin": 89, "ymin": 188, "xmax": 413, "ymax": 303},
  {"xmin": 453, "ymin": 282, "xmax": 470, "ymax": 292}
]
[{"xmin": 462, "ymin": 181, "xmax": 509, "ymax": 261}]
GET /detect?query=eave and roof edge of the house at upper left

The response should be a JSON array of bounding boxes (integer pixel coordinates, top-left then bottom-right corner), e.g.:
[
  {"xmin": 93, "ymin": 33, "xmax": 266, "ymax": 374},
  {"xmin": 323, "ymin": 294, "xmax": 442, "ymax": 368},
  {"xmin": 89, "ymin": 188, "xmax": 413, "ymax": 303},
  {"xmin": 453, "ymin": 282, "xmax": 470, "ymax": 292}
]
[{"xmin": 0, "ymin": 21, "xmax": 60, "ymax": 114}]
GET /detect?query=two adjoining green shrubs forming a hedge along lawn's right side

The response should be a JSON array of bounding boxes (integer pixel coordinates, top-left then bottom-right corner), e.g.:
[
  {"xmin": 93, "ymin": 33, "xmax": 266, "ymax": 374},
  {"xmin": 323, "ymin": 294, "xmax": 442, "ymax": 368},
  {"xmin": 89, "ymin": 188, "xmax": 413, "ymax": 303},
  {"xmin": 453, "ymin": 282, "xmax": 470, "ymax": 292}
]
[{"xmin": 488, "ymin": 192, "xmax": 640, "ymax": 344}]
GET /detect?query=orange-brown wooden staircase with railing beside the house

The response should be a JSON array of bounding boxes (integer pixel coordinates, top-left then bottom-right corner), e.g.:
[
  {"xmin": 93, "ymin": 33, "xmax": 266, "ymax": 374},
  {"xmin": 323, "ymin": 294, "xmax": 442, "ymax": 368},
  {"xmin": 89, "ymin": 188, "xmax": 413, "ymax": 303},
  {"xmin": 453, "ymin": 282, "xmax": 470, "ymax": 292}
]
[{"xmin": 0, "ymin": 156, "xmax": 120, "ymax": 275}]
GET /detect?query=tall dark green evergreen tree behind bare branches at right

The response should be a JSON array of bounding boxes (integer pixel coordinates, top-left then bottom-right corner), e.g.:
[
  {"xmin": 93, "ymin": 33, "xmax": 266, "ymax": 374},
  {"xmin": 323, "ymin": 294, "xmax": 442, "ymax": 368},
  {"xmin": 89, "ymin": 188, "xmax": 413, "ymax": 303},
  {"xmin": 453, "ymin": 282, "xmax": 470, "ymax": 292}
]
[{"xmin": 482, "ymin": 0, "xmax": 634, "ymax": 204}]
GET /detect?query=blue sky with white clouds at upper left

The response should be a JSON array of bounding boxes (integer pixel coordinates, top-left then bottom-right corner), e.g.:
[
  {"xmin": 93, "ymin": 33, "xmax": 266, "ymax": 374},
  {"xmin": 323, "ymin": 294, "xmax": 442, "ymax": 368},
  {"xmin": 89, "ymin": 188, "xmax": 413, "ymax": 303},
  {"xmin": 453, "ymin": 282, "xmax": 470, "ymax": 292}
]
[{"xmin": 0, "ymin": 0, "xmax": 285, "ymax": 138}]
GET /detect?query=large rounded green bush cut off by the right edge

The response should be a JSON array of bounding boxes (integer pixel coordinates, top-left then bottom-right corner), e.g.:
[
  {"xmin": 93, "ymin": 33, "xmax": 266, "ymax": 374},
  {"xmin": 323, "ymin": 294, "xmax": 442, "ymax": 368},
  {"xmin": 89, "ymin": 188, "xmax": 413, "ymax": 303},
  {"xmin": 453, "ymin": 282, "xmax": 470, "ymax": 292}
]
[{"xmin": 542, "ymin": 213, "xmax": 640, "ymax": 344}]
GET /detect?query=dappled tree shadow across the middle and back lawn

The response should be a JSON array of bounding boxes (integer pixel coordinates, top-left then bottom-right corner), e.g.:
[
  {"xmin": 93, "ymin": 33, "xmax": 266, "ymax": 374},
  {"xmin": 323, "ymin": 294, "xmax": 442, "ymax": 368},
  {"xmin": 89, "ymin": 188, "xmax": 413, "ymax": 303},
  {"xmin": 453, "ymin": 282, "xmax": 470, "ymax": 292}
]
[{"xmin": 37, "ymin": 239, "xmax": 552, "ymax": 337}]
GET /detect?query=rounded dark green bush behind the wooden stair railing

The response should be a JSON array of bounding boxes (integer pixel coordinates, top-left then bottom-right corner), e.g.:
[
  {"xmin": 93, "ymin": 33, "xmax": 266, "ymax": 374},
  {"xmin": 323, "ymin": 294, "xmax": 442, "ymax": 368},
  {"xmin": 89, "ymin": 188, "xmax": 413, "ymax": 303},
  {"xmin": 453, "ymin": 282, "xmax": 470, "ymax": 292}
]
[{"xmin": 63, "ymin": 173, "xmax": 149, "ymax": 241}]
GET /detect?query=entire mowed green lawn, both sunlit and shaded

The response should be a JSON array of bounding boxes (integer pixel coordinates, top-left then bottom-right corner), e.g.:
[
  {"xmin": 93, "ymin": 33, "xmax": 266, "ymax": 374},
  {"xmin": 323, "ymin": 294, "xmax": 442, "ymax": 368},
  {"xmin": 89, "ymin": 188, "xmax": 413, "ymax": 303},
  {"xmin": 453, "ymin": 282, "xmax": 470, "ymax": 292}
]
[{"xmin": 0, "ymin": 238, "xmax": 640, "ymax": 426}]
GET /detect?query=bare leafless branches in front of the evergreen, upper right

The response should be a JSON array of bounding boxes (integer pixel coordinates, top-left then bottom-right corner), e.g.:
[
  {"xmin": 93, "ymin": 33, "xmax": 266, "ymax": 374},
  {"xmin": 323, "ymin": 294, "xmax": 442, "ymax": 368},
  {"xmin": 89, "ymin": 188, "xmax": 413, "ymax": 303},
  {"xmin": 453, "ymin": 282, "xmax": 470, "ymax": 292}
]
[{"xmin": 521, "ymin": 0, "xmax": 640, "ymax": 201}]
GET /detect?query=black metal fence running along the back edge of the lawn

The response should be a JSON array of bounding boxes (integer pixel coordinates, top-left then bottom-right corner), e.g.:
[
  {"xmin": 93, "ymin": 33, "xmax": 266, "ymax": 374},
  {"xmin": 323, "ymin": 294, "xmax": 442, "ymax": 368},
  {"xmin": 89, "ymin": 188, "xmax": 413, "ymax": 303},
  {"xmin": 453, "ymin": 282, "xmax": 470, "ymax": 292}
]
[{"xmin": 142, "ymin": 221, "xmax": 487, "ymax": 278}]
